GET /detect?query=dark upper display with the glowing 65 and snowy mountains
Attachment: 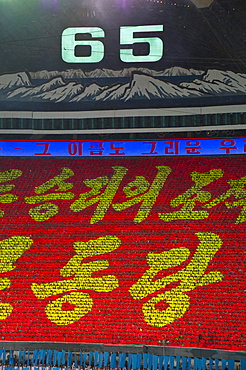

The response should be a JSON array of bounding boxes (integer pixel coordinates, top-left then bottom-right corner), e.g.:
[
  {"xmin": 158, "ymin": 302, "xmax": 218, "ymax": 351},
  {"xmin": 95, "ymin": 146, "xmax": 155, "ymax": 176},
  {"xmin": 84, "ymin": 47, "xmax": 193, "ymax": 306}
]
[{"xmin": 0, "ymin": 0, "xmax": 246, "ymax": 117}]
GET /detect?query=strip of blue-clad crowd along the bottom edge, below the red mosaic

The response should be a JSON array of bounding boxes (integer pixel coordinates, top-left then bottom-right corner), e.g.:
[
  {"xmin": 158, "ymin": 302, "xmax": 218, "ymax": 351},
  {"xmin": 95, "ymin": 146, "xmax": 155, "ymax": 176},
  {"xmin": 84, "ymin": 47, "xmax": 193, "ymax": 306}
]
[{"xmin": 0, "ymin": 350, "xmax": 245, "ymax": 370}]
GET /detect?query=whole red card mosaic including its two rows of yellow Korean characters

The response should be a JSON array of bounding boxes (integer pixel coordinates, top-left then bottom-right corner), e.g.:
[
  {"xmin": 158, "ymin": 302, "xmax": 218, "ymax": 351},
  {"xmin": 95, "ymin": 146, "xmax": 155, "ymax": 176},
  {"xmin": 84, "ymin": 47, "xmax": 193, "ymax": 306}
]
[{"xmin": 0, "ymin": 156, "xmax": 246, "ymax": 350}]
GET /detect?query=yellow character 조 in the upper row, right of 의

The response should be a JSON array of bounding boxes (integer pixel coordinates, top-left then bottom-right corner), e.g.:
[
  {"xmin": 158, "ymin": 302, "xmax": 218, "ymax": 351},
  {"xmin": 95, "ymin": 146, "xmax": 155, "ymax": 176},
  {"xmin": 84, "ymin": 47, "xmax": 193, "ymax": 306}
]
[{"xmin": 159, "ymin": 169, "xmax": 223, "ymax": 221}]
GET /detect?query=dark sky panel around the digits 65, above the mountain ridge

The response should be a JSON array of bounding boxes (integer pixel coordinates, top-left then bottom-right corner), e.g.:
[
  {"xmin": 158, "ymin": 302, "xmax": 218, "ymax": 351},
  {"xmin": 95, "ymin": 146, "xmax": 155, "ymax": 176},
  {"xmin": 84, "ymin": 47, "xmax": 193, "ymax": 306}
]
[{"xmin": 0, "ymin": 0, "xmax": 246, "ymax": 73}]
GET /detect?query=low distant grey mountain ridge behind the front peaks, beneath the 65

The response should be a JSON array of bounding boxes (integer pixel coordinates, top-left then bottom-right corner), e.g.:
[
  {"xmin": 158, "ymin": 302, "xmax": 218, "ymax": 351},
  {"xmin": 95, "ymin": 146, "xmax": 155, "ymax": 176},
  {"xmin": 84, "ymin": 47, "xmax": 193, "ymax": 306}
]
[{"xmin": 30, "ymin": 67, "xmax": 204, "ymax": 79}]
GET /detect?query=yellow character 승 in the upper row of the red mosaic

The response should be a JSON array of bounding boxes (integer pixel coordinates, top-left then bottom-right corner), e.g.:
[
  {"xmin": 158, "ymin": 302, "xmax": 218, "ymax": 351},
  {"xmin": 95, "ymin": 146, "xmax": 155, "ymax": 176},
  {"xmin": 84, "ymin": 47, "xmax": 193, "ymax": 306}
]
[{"xmin": 25, "ymin": 167, "xmax": 75, "ymax": 222}]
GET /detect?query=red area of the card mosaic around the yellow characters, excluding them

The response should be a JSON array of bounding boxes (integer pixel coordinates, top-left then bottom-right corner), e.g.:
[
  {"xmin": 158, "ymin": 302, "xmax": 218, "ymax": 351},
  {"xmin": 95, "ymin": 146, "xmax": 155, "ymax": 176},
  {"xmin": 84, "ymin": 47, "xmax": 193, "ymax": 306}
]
[{"xmin": 0, "ymin": 156, "xmax": 246, "ymax": 350}]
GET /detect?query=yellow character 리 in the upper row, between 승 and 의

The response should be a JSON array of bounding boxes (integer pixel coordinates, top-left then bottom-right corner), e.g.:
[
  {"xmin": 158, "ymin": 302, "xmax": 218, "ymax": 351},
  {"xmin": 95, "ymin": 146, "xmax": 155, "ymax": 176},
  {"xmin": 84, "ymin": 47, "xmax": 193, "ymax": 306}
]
[{"xmin": 70, "ymin": 166, "xmax": 128, "ymax": 224}]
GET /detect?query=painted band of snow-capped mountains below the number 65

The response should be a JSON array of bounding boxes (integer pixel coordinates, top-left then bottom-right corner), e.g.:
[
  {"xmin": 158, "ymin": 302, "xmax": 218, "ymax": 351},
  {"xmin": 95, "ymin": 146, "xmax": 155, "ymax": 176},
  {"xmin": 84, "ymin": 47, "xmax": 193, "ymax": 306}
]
[{"xmin": 0, "ymin": 67, "xmax": 246, "ymax": 110}]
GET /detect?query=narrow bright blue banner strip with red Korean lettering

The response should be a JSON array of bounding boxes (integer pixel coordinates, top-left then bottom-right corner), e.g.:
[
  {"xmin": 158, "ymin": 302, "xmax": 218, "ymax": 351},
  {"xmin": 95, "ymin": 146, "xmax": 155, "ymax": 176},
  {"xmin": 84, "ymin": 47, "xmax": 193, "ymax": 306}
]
[{"xmin": 0, "ymin": 138, "xmax": 246, "ymax": 157}]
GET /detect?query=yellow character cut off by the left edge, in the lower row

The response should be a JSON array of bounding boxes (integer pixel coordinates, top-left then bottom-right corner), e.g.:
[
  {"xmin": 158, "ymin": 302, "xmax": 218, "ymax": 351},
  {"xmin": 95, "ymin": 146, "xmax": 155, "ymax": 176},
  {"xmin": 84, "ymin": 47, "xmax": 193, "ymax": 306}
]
[{"xmin": 0, "ymin": 236, "xmax": 33, "ymax": 320}]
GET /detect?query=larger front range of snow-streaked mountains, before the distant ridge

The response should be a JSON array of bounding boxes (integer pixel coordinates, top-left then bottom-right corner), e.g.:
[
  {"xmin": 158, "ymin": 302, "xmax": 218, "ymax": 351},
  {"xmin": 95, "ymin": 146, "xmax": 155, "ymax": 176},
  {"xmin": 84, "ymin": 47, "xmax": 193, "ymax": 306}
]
[{"xmin": 0, "ymin": 68, "xmax": 246, "ymax": 104}]
